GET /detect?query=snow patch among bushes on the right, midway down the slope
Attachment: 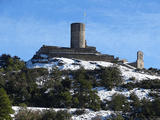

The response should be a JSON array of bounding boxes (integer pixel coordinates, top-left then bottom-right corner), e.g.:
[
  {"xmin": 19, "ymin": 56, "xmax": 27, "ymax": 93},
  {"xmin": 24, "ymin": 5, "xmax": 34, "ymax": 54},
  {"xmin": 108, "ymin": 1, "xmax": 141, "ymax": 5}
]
[{"xmin": 94, "ymin": 87, "xmax": 152, "ymax": 101}]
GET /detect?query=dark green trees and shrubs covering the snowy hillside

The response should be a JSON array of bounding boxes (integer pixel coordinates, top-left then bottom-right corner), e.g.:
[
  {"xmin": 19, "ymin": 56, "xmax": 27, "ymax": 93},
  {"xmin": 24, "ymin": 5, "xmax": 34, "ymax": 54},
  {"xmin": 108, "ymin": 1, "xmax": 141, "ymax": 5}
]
[{"xmin": 0, "ymin": 55, "xmax": 160, "ymax": 120}]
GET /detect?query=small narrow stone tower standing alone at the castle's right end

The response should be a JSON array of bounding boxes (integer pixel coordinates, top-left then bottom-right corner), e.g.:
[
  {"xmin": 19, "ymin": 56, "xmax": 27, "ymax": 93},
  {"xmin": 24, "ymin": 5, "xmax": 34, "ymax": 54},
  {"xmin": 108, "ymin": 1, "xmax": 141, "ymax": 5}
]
[{"xmin": 136, "ymin": 51, "xmax": 144, "ymax": 69}]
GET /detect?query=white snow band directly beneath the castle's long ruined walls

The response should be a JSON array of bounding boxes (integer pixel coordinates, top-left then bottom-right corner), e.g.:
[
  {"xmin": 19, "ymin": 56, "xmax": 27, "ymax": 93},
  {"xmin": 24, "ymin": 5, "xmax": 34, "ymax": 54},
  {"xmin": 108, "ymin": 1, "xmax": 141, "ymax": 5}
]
[{"xmin": 26, "ymin": 58, "xmax": 113, "ymax": 70}]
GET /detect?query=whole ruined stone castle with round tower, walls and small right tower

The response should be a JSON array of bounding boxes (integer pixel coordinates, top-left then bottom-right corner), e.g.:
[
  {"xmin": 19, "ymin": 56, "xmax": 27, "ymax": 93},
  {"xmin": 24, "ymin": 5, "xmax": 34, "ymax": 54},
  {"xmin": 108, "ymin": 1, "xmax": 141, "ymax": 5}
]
[{"xmin": 32, "ymin": 23, "xmax": 144, "ymax": 69}]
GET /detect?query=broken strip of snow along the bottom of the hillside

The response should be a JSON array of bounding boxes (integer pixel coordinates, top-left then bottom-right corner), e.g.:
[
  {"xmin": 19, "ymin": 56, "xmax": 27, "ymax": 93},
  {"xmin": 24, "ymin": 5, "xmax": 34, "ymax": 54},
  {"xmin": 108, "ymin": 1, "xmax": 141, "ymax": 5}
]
[{"xmin": 12, "ymin": 106, "xmax": 115, "ymax": 120}]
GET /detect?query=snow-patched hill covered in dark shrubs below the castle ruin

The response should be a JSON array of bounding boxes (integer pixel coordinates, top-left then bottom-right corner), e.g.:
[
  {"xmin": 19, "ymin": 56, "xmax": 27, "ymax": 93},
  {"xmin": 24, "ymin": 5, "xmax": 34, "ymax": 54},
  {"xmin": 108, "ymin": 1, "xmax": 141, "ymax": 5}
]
[{"xmin": 0, "ymin": 56, "xmax": 160, "ymax": 120}]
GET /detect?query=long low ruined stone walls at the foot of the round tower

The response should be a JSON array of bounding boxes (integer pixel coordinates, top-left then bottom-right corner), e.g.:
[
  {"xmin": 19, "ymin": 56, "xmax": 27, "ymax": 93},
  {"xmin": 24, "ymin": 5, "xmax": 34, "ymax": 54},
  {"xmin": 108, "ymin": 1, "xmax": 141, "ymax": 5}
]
[{"xmin": 33, "ymin": 46, "xmax": 115, "ymax": 62}]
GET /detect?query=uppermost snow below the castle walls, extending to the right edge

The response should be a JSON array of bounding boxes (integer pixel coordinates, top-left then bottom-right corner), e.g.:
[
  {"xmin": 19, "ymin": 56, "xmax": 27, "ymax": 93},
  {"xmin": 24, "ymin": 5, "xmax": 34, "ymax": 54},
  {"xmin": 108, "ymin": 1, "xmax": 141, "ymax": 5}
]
[{"xmin": 26, "ymin": 55, "xmax": 160, "ymax": 83}]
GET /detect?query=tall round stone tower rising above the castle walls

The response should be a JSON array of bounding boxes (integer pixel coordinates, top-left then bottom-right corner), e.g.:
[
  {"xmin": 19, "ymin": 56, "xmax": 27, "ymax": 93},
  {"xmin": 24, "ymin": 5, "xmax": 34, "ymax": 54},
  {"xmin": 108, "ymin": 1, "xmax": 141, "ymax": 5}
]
[{"xmin": 71, "ymin": 23, "xmax": 86, "ymax": 48}]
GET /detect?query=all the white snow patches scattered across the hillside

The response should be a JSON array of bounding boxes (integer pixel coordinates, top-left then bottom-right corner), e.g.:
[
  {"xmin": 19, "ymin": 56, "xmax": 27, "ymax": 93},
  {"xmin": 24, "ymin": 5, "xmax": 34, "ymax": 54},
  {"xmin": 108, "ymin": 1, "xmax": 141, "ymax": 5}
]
[{"xmin": 13, "ymin": 55, "xmax": 160, "ymax": 120}]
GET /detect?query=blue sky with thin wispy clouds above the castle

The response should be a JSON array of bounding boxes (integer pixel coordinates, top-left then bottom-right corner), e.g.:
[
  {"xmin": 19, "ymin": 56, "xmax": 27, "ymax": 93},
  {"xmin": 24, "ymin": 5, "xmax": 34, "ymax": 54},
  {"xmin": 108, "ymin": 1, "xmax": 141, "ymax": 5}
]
[{"xmin": 0, "ymin": 0, "xmax": 160, "ymax": 68}]
